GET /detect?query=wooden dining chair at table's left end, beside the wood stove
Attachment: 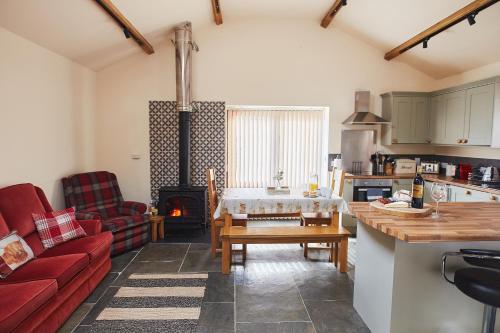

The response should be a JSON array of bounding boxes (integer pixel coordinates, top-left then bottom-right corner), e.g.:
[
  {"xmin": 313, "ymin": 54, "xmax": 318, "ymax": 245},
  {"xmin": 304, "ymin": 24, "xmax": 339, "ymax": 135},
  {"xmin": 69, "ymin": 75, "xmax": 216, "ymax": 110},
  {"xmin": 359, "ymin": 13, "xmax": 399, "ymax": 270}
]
[{"xmin": 207, "ymin": 169, "xmax": 248, "ymax": 260}]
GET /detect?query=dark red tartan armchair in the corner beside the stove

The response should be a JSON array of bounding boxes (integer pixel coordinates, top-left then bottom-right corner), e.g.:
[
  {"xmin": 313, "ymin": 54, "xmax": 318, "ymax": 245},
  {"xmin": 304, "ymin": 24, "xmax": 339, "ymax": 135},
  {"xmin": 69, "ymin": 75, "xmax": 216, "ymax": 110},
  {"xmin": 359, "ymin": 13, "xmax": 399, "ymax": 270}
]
[{"xmin": 62, "ymin": 171, "xmax": 151, "ymax": 256}]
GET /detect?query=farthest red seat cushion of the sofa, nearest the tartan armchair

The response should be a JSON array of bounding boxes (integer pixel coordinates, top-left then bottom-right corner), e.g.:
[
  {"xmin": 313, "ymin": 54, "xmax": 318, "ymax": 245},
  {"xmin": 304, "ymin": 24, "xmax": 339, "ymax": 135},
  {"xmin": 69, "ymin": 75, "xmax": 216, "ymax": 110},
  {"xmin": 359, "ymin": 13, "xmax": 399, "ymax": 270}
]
[{"xmin": 40, "ymin": 231, "xmax": 113, "ymax": 261}]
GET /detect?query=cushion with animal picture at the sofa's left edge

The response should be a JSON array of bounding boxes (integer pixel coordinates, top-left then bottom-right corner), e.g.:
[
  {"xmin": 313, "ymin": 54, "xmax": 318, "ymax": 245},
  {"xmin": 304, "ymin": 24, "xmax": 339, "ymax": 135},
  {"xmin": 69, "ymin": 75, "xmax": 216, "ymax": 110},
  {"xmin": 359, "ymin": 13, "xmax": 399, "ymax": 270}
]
[{"xmin": 0, "ymin": 231, "xmax": 35, "ymax": 279}]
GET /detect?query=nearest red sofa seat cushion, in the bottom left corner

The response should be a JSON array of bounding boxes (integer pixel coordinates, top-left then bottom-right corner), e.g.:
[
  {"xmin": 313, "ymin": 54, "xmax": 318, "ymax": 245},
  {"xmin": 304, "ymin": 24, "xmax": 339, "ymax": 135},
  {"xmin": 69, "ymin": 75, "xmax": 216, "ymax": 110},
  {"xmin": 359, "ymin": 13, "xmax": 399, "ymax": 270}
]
[{"xmin": 0, "ymin": 280, "xmax": 57, "ymax": 332}]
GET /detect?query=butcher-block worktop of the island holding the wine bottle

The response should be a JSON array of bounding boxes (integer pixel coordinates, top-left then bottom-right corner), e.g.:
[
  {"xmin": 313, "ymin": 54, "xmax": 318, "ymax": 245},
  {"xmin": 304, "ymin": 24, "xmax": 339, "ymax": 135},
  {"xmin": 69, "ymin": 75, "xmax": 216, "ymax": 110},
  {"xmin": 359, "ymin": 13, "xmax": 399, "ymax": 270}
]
[{"xmin": 349, "ymin": 202, "xmax": 500, "ymax": 243}]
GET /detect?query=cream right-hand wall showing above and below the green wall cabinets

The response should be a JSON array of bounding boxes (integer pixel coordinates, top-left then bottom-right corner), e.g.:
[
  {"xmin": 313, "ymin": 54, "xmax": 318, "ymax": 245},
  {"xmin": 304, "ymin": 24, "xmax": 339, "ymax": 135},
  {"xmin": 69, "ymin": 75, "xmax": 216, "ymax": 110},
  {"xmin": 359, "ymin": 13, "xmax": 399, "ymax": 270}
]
[{"xmin": 432, "ymin": 61, "xmax": 500, "ymax": 159}]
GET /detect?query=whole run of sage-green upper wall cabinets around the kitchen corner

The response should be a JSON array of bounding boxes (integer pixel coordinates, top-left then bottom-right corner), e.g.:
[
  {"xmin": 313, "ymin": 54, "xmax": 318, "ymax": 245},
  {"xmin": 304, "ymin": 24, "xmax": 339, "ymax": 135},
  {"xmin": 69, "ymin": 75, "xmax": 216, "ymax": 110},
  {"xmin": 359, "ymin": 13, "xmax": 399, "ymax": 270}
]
[{"xmin": 382, "ymin": 77, "xmax": 500, "ymax": 147}]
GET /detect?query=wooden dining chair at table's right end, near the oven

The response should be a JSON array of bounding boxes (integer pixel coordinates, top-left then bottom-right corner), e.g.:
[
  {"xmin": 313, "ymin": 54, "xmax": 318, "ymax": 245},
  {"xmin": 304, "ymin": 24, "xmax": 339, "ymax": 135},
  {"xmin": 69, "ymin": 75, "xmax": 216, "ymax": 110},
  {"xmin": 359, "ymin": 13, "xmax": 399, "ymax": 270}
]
[{"xmin": 300, "ymin": 168, "xmax": 345, "ymax": 266}]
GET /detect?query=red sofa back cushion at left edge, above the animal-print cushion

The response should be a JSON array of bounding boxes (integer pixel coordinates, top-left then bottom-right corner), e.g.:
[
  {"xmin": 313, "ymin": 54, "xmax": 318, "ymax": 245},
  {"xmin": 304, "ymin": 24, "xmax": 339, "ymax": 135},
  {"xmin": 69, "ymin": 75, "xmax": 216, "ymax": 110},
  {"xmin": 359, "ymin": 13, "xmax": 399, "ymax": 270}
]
[{"xmin": 0, "ymin": 184, "xmax": 45, "ymax": 237}]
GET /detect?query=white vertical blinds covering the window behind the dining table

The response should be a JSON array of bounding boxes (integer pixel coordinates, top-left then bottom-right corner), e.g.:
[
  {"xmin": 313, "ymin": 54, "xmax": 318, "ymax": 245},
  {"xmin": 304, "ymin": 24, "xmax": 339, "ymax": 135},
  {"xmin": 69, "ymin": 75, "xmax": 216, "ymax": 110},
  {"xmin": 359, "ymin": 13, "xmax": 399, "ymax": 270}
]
[{"xmin": 227, "ymin": 108, "xmax": 328, "ymax": 187}]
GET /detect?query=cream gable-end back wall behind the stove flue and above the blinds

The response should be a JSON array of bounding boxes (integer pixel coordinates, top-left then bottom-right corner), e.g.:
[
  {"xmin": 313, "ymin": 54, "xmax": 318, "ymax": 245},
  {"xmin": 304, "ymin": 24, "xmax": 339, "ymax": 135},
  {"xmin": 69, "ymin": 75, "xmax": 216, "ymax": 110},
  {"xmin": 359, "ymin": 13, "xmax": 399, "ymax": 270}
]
[{"xmin": 96, "ymin": 20, "xmax": 433, "ymax": 201}]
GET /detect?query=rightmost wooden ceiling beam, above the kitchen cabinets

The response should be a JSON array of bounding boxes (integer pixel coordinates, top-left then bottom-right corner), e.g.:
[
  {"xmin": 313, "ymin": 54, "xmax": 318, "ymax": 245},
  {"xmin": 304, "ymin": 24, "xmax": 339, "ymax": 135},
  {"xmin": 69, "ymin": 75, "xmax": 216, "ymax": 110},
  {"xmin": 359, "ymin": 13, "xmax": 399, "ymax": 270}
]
[{"xmin": 384, "ymin": 0, "xmax": 500, "ymax": 60}]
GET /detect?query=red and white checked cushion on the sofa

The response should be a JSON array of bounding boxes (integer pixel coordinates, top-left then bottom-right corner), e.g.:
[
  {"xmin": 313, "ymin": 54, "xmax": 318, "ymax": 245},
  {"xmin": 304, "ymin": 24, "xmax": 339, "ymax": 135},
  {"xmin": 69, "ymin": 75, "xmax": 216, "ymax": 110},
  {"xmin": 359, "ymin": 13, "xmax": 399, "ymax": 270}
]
[{"xmin": 33, "ymin": 208, "xmax": 87, "ymax": 249}]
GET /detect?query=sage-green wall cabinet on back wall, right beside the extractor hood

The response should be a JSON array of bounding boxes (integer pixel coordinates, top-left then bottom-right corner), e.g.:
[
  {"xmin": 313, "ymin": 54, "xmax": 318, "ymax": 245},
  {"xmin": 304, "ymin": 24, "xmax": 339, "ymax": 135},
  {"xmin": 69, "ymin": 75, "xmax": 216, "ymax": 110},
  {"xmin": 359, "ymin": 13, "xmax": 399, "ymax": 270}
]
[{"xmin": 382, "ymin": 92, "xmax": 430, "ymax": 145}]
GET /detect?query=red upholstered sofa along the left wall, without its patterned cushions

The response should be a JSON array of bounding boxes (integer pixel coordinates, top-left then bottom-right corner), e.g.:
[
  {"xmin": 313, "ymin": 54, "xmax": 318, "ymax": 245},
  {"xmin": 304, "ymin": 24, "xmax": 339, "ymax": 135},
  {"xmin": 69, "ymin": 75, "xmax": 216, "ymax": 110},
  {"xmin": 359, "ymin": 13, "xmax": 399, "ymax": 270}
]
[{"xmin": 0, "ymin": 184, "xmax": 113, "ymax": 333}]
